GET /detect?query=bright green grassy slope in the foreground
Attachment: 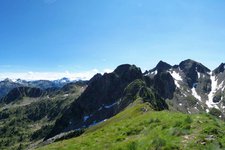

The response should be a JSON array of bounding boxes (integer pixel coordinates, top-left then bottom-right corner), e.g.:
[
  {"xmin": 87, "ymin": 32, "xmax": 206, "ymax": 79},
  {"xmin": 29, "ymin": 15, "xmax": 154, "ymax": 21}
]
[{"xmin": 40, "ymin": 103, "xmax": 225, "ymax": 150}]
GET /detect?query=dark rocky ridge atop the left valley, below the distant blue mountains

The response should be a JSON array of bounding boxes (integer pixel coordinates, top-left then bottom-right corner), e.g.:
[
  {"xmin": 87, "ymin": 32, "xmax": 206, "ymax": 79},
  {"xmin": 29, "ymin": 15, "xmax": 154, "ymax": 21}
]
[{"xmin": 1, "ymin": 87, "xmax": 44, "ymax": 104}]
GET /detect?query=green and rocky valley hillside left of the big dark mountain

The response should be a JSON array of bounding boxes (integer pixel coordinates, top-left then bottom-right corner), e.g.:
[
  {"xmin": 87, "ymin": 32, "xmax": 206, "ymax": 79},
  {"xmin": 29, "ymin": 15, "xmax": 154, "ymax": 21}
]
[{"xmin": 0, "ymin": 83, "xmax": 86, "ymax": 150}]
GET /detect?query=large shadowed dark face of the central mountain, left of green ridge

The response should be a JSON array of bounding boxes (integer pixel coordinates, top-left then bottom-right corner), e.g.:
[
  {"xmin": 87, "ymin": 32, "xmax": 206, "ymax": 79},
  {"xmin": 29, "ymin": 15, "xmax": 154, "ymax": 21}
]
[{"xmin": 47, "ymin": 65, "xmax": 142, "ymax": 138}]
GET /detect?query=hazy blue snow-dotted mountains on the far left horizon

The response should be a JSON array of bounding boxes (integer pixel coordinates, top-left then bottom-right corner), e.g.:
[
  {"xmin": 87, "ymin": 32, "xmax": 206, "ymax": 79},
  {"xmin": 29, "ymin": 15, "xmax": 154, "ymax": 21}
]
[{"xmin": 0, "ymin": 78, "xmax": 76, "ymax": 98}]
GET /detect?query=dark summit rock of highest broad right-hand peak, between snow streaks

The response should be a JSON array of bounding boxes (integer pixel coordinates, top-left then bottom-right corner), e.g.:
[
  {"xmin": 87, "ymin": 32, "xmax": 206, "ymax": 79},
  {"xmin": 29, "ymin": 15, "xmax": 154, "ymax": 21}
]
[{"xmin": 179, "ymin": 59, "xmax": 210, "ymax": 88}]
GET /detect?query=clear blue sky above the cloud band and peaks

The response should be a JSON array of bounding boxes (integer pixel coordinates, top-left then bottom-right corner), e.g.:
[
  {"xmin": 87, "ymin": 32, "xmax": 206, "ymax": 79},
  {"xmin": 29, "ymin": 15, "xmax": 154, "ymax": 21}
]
[{"xmin": 0, "ymin": 0, "xmax": 225, "ymax": 78}]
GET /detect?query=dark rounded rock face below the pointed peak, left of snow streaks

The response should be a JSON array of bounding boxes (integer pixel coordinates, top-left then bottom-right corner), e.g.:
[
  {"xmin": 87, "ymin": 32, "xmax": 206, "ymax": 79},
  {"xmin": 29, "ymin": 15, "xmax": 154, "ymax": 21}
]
[{"xmin": 154, "ymin": 72, "xmax": 176, "ymax": 99}]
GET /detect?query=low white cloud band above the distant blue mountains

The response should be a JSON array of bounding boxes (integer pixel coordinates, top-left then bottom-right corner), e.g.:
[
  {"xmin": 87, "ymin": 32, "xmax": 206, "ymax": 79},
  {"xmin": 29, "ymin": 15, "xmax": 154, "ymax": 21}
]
[{"xmin": 0, "ymin": 69, "xmax": 112, "ymax": 80}]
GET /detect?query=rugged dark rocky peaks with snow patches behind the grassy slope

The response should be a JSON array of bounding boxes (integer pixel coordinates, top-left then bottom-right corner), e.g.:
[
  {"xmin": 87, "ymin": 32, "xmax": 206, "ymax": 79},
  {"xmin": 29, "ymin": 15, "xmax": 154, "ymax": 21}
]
[{"xmin": 47, "ymin": 59, "xmax": 225, "ymax": 138}]
